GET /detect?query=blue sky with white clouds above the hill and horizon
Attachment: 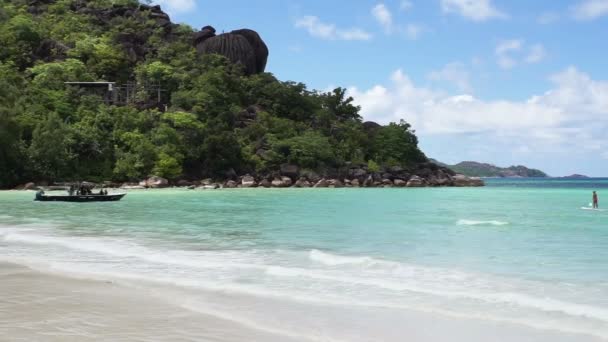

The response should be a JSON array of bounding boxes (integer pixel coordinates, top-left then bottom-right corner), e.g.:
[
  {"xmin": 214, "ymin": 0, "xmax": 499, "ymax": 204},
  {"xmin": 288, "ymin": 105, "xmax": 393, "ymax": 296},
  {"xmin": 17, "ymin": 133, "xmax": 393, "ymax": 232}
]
[{"xmin": 156, "ymin": 0, "xmax": 608, "ymax": 176}]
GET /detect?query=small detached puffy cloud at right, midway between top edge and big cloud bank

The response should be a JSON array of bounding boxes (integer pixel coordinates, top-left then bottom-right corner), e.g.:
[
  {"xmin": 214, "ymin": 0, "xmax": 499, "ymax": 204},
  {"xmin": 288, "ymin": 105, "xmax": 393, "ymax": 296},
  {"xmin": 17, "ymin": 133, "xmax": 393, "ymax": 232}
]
[{"xmin": 494, "ymin": 39, "xmax": 547, "ymax": 69}]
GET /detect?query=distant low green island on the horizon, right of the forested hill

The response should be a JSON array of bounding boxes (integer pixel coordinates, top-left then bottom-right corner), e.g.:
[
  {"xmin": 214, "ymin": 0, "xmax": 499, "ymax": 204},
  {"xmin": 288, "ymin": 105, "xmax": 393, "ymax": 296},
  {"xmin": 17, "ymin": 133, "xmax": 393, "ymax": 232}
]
[{"xmin": 433, "ymin": 160, "xmax": 548, "ymax": 178}]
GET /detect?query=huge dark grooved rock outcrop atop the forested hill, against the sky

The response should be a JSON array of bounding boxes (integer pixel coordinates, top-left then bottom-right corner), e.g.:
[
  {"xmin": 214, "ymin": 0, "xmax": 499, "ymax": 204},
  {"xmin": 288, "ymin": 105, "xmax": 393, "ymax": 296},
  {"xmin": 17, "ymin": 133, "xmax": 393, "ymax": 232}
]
[{"xmin": 194, "ymin": 26, "xmax": 268, "ymax": 75}]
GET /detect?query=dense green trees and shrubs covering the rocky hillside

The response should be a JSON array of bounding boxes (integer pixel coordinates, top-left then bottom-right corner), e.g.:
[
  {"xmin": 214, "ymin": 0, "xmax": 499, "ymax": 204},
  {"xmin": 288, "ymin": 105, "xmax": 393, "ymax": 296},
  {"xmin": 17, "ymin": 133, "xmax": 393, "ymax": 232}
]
[{"xmin": 0, "ymin": 0, "xmax": 426, "ymax": 188}]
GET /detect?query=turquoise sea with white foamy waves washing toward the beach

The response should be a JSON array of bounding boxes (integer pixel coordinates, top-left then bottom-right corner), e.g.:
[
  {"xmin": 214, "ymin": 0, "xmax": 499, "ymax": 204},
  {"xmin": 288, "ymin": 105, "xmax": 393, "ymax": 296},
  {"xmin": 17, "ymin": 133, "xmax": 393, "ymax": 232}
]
[{"xmin": 0, "ymin": 179, "xmax": 608, "ymax": 341}]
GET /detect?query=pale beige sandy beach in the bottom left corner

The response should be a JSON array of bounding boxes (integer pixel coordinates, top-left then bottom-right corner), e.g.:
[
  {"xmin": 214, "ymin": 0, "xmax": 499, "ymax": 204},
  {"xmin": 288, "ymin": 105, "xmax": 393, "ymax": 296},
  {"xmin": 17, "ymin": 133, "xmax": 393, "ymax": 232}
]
[{"xmin": 0, "ymin": 263, "xmax": 300, "ymax": 342}]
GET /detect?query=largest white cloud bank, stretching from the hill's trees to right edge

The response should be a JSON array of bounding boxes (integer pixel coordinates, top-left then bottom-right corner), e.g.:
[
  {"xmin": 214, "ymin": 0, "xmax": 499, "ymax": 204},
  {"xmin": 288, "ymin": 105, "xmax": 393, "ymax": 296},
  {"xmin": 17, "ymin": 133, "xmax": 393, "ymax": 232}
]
[{"xmin": 349, "ymin": 67, "xmax": 608, "ymax": 152}]
